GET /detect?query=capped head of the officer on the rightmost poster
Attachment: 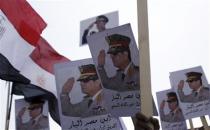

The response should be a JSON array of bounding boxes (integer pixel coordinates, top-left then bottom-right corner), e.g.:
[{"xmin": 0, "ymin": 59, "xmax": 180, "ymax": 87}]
[{"xmin": 186, "ymin": 72, "xmax": 202, "ymax": 91}]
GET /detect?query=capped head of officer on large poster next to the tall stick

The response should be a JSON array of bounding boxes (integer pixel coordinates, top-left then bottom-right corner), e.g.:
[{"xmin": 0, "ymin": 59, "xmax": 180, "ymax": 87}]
[{"xmin": 105, "ymin": 34, "xmax": 131, "ymax": 69}]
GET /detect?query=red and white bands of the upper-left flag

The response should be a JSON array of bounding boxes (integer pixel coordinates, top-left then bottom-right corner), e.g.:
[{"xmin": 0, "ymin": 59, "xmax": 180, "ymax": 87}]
[{"xmin": 0, "ymin": 0, "xmax": 47, "ymax": 70}]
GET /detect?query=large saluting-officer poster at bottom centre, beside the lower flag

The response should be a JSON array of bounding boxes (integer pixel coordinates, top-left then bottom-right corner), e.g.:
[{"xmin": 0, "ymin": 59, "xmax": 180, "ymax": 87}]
[{"xmin": 55, "ymin": 59, "xmax": 121, "ymax": 130}]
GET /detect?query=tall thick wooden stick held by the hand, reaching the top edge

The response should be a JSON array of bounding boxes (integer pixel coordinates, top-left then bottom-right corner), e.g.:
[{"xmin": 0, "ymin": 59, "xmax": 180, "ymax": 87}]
[{"xmin": 137, "ymin": 0, "xmax": 153, "ymax": 116}]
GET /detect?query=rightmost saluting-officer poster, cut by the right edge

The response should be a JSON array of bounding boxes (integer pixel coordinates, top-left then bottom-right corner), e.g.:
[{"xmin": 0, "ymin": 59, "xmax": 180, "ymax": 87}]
[{"xmin": 170, "ymin": 66, "xmax": 210, "ymax": 119}]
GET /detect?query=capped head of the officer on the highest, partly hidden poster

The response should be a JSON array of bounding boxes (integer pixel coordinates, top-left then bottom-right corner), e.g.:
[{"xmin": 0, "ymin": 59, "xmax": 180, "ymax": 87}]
[{"xmin": 95, "ymin": 15, "xmax": 109, "ymax": 32}]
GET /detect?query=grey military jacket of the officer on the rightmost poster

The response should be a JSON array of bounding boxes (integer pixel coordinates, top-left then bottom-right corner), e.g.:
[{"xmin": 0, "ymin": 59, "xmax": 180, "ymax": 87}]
[{"xmin": 178, "ymin": 86, "xmax": 210, "ymax": 103}]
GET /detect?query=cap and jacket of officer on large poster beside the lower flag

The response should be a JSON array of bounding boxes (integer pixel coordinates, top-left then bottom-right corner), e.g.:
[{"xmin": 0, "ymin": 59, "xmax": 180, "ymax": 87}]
[{"xmin": 60, "ymin": 64, "xmax": 107, "ymax": 117}]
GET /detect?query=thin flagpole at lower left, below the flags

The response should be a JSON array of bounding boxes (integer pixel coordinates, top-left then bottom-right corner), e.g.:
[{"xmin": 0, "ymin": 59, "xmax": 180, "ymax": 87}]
[{"xmin": 5, "ymin": 82, "xmax": 12, "ymax": 130}]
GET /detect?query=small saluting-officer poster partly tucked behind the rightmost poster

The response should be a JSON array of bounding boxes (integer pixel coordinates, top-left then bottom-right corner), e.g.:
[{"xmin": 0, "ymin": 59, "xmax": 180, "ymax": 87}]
[{"xmin": 156, "ymin": 89, "xmax": 187, "ymax": 130}]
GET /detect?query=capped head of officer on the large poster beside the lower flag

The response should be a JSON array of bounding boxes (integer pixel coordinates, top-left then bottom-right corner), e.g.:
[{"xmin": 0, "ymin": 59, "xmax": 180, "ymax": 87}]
[{"xmin": 77, "ymin": 64, "xmax": 101, "ymax": 96}]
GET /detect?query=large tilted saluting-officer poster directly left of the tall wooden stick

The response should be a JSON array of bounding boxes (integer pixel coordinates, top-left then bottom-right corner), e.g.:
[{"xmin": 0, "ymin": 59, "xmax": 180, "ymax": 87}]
[{"xmin": 88, "ymin": 24, "xmax": 140, "ymax": 116}]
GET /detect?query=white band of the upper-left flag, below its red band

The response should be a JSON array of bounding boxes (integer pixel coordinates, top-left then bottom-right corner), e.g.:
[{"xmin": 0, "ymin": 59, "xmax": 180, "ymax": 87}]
[{"xmin": 0, "ymin": 10, "xmax": 35, "ymax": 70}]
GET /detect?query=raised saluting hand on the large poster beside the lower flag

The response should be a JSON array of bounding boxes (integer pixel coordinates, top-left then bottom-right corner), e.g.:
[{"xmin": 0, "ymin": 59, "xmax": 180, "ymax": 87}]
[{"xmin": 62, "ymin": 77, "xmax": 75, "ymax": 94}]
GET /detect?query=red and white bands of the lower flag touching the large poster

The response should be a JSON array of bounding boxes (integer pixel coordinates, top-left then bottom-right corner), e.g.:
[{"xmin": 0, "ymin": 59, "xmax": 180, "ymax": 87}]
[{"xmin": 20, "ymin": 38, "xmax": 70, "ymax": 95}]
